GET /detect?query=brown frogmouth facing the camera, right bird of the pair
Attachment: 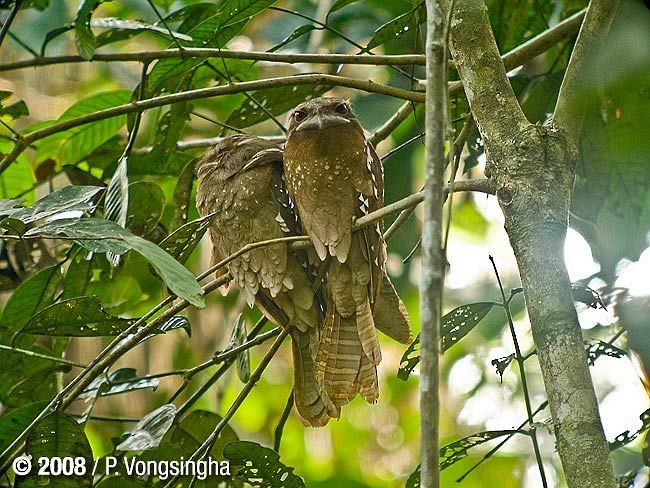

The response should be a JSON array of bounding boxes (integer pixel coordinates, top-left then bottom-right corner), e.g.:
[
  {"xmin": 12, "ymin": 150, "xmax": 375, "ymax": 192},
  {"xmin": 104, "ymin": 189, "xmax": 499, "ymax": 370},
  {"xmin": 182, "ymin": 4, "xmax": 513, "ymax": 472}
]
[{"xmin": 284, "ymin": 97, "xmax": 411, "ymax": 411}]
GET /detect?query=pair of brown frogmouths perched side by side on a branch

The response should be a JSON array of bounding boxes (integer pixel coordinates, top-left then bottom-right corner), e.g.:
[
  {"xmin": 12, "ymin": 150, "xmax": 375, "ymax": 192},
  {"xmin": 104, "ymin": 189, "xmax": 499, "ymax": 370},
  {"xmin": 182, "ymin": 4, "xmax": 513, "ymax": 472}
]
[{"xmin": 195, "ymin": 98, "xmax": 411, "ymax": 426}]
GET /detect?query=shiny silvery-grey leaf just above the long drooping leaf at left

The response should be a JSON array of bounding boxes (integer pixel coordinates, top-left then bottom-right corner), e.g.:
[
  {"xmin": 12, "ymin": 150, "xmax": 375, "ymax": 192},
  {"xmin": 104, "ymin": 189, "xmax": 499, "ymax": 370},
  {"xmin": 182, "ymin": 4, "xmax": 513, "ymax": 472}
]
[{"xmin": 10, "ymin": 186, "xmax": 103, "ymax": 224}]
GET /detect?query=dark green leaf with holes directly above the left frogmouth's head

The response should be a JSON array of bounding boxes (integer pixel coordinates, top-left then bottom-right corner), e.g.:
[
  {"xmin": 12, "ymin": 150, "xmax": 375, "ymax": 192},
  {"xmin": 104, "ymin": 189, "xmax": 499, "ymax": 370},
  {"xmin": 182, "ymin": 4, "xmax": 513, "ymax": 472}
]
[{"xmin": 226, "ymin": 85, "xmax": 329, "ymax": 128}]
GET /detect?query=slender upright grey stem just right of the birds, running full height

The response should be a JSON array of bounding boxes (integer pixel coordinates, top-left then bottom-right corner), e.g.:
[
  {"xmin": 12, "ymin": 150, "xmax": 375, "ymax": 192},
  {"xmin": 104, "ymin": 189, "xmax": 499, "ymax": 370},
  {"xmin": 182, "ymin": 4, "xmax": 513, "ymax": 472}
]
[{"xmin": 420, "ymin": 0, "xmax": 452, "ymax": 488}]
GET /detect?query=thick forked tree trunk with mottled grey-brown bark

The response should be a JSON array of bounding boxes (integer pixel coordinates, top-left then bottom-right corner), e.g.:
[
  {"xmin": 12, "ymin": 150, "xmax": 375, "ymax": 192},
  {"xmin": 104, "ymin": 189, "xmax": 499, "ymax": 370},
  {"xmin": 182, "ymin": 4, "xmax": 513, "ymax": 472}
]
[{"xmin": 451, "ymin": 0, "xmax": 616, "ymax": 488}]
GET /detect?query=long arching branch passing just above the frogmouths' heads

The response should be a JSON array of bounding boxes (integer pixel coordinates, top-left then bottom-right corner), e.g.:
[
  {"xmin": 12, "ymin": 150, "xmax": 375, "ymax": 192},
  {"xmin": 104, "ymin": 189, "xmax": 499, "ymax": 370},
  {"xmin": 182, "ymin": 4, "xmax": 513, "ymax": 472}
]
[{"xmin": 0, "ymin": 73, "xmax": 424, "ymax": 174}]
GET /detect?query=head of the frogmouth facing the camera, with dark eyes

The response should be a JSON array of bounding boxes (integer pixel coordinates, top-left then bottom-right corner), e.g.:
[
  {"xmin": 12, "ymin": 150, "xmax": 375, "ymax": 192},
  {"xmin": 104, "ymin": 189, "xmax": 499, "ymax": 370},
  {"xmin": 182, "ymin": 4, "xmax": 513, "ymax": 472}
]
[{"xmin": 287, "ymin": 97, "xmax": 358, "ymax": 137}]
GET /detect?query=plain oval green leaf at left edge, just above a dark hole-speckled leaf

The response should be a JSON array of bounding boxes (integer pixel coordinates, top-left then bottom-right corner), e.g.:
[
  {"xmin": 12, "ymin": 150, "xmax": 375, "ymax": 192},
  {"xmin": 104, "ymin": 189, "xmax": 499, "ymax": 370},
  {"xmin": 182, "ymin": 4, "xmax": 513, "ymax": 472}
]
[{"xmin": 0, "ymin": 266, "xmax": 61, "ymax": 331}]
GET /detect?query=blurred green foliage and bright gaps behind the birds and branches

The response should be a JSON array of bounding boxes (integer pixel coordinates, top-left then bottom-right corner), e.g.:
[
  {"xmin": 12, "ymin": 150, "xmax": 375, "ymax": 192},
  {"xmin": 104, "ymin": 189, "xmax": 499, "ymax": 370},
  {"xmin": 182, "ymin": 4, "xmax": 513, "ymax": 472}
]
[{"xmin": 0, "ymin": 0, "xmax": 650, "ymax": 487}]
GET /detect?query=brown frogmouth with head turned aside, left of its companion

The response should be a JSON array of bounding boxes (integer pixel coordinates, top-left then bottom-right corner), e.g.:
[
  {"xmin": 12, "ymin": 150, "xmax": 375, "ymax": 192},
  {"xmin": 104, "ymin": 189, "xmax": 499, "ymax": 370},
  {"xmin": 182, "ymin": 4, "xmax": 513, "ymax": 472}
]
[{"xmin": 195, "ymin": 135, "xmax": 338, "ymax": 426}]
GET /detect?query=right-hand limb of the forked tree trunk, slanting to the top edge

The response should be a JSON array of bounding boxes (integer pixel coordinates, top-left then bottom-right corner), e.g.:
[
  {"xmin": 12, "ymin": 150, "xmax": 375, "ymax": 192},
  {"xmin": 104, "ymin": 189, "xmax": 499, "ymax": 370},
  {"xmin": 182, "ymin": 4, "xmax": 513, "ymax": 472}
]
[{"xmin": 553, "ymin": 0, "xmax": 620, "ymax": 147}]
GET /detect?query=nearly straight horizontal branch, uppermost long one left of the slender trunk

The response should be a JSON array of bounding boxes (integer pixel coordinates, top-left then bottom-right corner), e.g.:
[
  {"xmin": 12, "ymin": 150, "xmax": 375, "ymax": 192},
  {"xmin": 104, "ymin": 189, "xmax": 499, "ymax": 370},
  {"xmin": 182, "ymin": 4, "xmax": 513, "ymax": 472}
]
[{"xmin": 0, "ymin": 47, "xmax": 424, "ymax": 72}]
